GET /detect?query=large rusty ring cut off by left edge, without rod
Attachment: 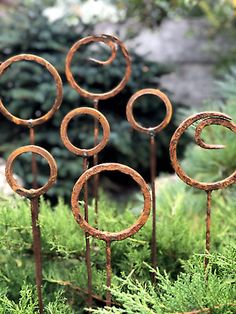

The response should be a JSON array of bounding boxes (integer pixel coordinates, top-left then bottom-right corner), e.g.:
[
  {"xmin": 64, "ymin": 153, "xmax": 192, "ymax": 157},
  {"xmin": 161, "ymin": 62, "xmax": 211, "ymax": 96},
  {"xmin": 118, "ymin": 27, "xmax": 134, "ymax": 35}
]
[{"xmin": 0, "ymin": 54, "xmax": 63, "ymax": 127}]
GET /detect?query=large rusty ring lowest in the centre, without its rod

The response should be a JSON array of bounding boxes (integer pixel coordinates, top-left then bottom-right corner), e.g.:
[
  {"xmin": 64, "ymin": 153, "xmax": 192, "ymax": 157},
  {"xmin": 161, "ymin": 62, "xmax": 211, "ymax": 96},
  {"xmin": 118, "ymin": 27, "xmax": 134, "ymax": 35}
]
[{"xmin": 71, "ymin": 163, "xmax": 151, "ymax": 241}]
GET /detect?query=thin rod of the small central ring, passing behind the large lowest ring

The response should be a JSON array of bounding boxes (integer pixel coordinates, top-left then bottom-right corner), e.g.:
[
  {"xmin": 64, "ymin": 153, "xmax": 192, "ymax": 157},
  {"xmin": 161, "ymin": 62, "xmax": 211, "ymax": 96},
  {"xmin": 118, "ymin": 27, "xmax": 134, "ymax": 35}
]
[{"xmin": 83, "ymin": 157, "xmax": 92, "ymax": 307}]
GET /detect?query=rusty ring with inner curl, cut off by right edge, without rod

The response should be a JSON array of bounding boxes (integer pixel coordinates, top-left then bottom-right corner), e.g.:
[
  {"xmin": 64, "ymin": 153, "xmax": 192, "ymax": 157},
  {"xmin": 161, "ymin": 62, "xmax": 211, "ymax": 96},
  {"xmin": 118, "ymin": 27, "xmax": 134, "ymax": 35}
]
[{"xmin": 170, "ymin": 111, "xmax": 236, "ymax": 191}]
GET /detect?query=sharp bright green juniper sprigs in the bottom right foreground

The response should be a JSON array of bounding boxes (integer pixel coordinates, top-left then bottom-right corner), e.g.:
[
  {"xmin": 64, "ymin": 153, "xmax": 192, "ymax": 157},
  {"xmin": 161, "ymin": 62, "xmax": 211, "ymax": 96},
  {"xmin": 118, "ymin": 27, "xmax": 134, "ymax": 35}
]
[{"xmin": 92, "ymin": 246, "xmax": 236, "ymax": 314}]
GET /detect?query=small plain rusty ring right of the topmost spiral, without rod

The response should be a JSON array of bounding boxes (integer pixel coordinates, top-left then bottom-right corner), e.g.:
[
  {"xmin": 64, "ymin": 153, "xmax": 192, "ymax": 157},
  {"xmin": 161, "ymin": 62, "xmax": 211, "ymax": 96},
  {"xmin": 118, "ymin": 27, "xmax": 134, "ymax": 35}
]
[{"xmin": 126, "ymin": 88, "xmax": 172, "ymax": 134}]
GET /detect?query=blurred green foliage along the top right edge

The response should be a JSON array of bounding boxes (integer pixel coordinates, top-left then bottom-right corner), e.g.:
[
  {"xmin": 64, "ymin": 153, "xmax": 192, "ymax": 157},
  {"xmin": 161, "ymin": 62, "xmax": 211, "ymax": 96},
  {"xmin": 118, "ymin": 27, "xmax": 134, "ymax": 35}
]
[{"xmin": 112, "ymin": 0, "xmax": 236, "ymax": 29}]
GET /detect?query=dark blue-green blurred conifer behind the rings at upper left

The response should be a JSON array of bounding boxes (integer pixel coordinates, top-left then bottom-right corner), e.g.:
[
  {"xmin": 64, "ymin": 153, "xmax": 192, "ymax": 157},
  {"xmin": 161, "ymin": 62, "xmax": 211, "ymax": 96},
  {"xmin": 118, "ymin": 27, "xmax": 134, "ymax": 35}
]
[{"xmin": 0, "ymin": 1, "xmax": 178, "ymax": 201}]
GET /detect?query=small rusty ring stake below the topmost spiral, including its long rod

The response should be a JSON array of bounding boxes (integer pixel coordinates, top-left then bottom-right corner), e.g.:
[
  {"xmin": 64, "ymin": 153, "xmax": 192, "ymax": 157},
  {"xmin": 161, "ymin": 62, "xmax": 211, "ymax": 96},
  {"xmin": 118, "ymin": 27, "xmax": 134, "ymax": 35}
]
[{"xmin": 61, "ymin": 107, "xmax": 110, "ymax": 307}]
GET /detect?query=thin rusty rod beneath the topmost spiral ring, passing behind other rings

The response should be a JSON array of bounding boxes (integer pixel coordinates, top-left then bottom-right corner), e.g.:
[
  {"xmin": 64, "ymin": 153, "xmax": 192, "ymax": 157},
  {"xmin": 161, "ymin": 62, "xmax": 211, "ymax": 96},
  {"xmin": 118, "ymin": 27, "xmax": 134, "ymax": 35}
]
[{"xmin": 93, "ymin": 99, "xmax": 99, "ymax": 226}]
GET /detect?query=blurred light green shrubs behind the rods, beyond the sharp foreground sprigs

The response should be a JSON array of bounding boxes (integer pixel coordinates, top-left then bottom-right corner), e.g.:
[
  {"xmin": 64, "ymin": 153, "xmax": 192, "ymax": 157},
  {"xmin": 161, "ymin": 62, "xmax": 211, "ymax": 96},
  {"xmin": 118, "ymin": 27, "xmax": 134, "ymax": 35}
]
[{"xmin": 0, "ymin": 172, "xmax": 236, "ymax": 313}]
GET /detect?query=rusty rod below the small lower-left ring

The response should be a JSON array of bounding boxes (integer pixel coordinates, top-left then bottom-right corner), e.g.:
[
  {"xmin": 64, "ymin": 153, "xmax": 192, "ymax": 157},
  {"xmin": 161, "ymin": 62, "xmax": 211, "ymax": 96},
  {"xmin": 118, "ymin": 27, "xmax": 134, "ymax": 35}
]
[{"xmin": 30, "ymin": 197, "xmax": 43, "ymax": 314}]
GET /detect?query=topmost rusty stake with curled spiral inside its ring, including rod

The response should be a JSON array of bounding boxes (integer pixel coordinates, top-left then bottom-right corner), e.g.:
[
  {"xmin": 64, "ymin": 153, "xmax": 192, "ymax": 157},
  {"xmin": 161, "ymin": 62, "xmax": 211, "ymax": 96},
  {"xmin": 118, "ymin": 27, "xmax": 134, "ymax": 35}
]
[{"xmin": 65, "ymin": 34, "xmax": 131, "ymax": 224}]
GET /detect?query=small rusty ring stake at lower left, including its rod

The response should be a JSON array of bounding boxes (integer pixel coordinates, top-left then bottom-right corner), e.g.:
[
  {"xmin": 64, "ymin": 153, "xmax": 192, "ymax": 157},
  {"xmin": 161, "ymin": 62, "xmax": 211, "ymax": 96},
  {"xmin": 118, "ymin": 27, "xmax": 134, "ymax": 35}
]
[{"xmin": 6, "ymin": 145, "xmax": 57, "ymax": 314}]
